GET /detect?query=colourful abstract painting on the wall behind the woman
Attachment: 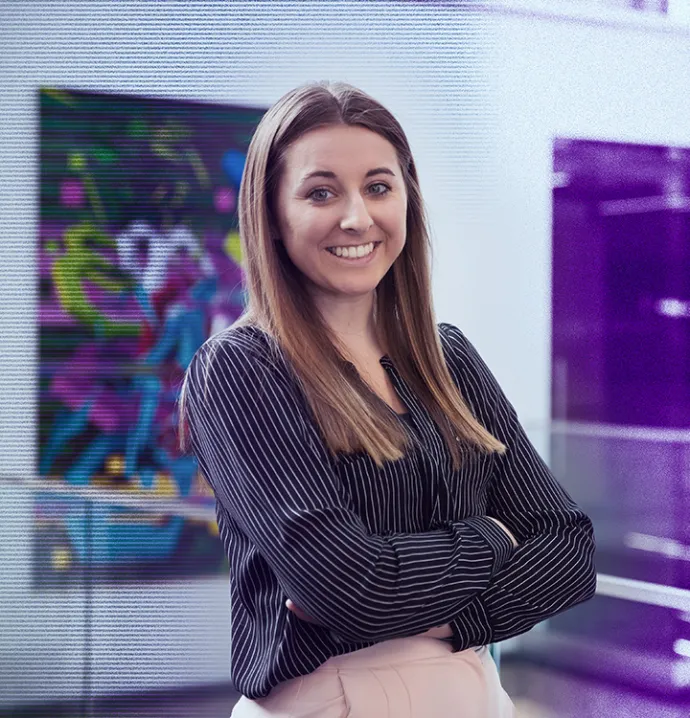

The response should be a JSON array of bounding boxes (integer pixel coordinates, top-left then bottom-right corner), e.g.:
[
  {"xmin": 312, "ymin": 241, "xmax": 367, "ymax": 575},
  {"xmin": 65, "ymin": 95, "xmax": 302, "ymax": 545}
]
[{"xmin": 34, "ymin": 89, "xmax": 265, "ymax": 586}]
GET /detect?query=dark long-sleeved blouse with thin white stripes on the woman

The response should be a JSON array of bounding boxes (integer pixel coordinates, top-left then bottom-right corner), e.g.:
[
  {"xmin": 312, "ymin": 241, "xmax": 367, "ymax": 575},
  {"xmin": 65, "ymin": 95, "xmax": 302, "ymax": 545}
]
[{"xmin": 187, "ymin": 324, "xmax": 596, "ymax": 698}]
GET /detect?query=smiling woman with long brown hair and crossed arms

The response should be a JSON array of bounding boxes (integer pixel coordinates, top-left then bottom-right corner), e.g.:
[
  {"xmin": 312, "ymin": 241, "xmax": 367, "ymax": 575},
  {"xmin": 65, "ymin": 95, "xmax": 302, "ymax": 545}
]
[{"xmin": 181, "ymin": 83, "xmax": 596, "ymax": 718}]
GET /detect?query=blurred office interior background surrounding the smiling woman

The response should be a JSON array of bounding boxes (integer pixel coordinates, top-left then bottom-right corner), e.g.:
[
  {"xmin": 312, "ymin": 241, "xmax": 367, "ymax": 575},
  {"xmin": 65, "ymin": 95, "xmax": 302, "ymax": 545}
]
[{"xmin": 0, "ymin": 0, "xmax": 690, "ymax": 718}]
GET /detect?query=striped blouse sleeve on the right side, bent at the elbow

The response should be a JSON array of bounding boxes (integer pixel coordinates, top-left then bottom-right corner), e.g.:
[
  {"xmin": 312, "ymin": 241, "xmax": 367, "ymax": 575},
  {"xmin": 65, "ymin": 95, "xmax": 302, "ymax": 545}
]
[{"xmin": 442, "ymin": 325, "xmax": 596, "ymax": 650}]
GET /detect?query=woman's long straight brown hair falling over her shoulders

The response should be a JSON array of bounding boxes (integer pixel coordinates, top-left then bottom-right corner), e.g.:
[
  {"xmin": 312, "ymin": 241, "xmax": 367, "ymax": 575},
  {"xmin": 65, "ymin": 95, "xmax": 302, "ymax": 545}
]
[{"xmin": 180, "ymin": 82, "xmax": 505, "ymax": 469}]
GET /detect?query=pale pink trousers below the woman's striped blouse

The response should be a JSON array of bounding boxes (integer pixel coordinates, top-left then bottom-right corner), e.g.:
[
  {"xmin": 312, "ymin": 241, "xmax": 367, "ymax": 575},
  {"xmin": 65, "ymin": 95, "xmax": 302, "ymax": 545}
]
[{"xmin": 231, "ymin": 636, "xmax": 517, "ymax": 718}]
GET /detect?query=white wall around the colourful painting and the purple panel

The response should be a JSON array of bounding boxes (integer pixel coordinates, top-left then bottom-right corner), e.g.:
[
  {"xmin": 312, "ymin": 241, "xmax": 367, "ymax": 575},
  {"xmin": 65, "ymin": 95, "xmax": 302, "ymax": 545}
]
[{"xmin": 0, "ymin": 2, "xmax": 690, "ymax": 706}]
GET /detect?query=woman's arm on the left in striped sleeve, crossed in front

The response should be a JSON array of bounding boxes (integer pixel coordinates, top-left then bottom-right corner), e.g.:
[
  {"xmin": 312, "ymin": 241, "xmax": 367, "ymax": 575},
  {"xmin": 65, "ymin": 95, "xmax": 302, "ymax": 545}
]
[{"xmin": 186, "ymin": 337, "xmax": 513, "ymax": 642}]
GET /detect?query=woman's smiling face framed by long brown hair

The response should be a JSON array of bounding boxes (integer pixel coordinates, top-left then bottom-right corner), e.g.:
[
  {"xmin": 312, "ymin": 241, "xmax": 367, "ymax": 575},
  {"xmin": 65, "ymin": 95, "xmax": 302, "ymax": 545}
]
[{"xmin": 276, "ymin": 125, "xmax": 407, "ymax": 298}]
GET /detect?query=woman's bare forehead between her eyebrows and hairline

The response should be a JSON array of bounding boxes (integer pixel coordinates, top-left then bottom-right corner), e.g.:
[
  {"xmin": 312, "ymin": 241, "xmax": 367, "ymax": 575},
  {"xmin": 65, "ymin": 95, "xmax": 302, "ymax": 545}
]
[{"xmin": 284, "ymin": 125, "xmax": 400, "ymax": 181}]
